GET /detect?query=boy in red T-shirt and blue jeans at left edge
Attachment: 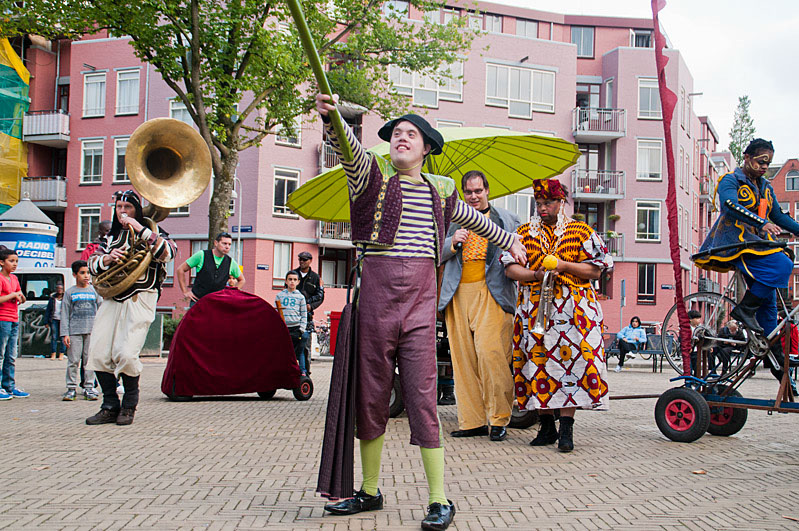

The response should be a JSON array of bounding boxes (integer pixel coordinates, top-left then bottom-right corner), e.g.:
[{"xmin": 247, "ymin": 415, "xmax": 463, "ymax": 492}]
[{"xmin": 0, "ymin": 249, "xmax": 30, "ymax": 400}]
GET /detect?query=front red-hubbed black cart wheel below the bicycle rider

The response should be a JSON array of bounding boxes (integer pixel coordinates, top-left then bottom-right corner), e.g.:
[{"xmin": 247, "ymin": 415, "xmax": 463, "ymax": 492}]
[{"xmin": 655, "ymin": 387, "xmax": 710, "ymax": 442}]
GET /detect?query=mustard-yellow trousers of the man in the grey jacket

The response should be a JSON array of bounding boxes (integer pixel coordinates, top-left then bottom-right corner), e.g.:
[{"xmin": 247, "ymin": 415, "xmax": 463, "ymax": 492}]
[{"xmin": 444, "ymin": 280, "xmax": 513, "ymax": 430}]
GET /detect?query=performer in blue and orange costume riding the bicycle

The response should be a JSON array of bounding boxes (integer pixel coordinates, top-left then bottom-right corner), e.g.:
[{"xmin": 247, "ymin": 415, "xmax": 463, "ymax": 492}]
[{"xmin": 695, "ymin": 138, "xmax": 799, "ymax": 388}]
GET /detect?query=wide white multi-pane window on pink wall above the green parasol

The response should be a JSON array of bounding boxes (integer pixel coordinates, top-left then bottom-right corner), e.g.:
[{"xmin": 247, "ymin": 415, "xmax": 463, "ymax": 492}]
[{"xmin": 486, "ymin": 64, "xmax": 555, "ymax": 118}]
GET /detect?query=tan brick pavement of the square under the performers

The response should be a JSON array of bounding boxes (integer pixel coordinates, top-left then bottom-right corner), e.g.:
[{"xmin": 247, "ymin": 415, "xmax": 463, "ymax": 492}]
[{"xmin": 0, "ymin": 359, "xmax": 799, "ymax": 531}]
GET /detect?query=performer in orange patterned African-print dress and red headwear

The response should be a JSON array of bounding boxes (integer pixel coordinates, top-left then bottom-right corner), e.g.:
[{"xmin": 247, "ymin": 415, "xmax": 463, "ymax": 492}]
[{"xmin": 505, "ymin": 179, "xmax": 613, "ymax": 452}]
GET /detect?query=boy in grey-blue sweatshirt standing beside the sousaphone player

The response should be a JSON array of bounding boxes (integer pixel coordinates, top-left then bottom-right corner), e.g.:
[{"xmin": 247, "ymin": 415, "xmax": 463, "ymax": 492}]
[{"xmin": 61, "ymin": 260, "xmax": 101, "ymax": 401}]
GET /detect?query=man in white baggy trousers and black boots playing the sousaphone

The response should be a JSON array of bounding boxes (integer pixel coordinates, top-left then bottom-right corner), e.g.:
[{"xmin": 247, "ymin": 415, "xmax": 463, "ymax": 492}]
[{"xmin": 86, "ymin": 190, "xmax": 176, "ymax": 425}]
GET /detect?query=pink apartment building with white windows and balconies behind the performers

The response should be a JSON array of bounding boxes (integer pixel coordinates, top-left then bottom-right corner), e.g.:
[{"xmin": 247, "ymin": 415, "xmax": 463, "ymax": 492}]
[{"xmin": 17, "ymin": 0, "xmax": 724, "ymax": 331}]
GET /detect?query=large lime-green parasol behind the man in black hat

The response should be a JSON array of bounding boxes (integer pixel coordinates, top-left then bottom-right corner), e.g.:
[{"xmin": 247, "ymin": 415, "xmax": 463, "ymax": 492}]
[{"xmin": 288, "ymin": 127, "xmax": 580, "ymax": 222}]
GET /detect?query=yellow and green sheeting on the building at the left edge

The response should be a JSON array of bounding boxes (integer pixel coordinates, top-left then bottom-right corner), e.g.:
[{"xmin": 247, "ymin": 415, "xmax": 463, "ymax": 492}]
[{"xmin": 0, "ymin": 39, "xmax": 30, "ymax": 210}]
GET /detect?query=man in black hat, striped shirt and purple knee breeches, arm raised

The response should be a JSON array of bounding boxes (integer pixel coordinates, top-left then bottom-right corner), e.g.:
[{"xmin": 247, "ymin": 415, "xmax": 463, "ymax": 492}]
[{"xmin": 316, "ymin": 94, "xmax": 526, "ymax": 530}]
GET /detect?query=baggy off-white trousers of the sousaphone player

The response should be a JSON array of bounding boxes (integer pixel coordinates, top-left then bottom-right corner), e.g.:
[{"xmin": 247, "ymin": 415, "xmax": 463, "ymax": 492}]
[{"xmin": 87, "ymin": 290, "xmax": 158, "ymax": 377}]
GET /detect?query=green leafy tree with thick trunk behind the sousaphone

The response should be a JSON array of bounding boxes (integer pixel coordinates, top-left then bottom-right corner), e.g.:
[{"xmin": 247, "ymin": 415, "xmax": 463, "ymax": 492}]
[{"xmin": 0, "ymin": 0, "xmax": 475, "ymax": 244}]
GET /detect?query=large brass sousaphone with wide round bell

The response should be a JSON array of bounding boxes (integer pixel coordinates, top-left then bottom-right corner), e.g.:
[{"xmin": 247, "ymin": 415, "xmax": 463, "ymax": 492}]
[{"xmin": 93, "ymin": 118, "xmax": 211, "ymax": 298}]
